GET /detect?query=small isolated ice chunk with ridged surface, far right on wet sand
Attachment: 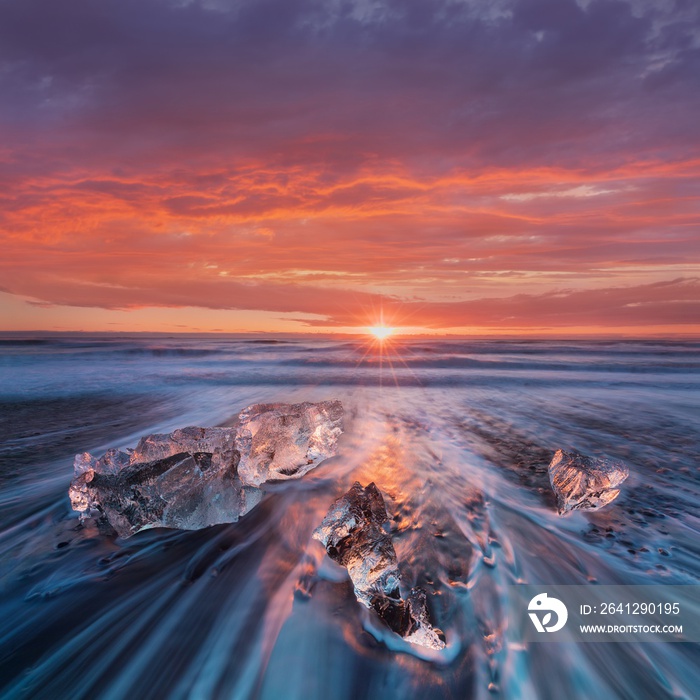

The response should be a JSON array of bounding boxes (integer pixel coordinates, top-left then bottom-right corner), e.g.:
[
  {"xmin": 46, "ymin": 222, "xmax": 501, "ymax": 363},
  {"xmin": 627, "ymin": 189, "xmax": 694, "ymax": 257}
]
[{"xmin": 549, "ymin": 450, "xmax": 629, "ymax": 515}]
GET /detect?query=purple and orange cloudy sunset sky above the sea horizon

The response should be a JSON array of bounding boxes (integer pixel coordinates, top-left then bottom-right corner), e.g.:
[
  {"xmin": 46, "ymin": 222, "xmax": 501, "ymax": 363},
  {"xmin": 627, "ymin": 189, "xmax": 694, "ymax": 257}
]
[{"xmin": 0, "ymin": 0, "xmax": 700, "ymax": 336}]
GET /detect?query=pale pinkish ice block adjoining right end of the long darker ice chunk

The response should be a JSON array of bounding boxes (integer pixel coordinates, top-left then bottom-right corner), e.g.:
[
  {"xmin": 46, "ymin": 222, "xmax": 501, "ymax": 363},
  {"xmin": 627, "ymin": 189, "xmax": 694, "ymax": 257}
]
[{"xmin": 236, "ymin": 401, "xmax": 343, "ymax": 486}]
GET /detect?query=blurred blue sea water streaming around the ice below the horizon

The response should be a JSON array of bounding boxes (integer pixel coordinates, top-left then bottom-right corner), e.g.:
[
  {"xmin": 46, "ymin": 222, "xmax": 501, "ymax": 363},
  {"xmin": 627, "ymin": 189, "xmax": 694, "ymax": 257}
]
[{"xmin": 0, "ymin": 334, "xmax": 700, "ymax": 700}]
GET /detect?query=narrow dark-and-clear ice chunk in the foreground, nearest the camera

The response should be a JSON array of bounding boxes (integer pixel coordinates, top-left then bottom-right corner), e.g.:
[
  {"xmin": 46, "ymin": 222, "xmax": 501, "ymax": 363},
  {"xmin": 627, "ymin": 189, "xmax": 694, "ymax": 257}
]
[{"xmin": 314, "ymin": 481, "xmax": 445, "ymax": 649}]
